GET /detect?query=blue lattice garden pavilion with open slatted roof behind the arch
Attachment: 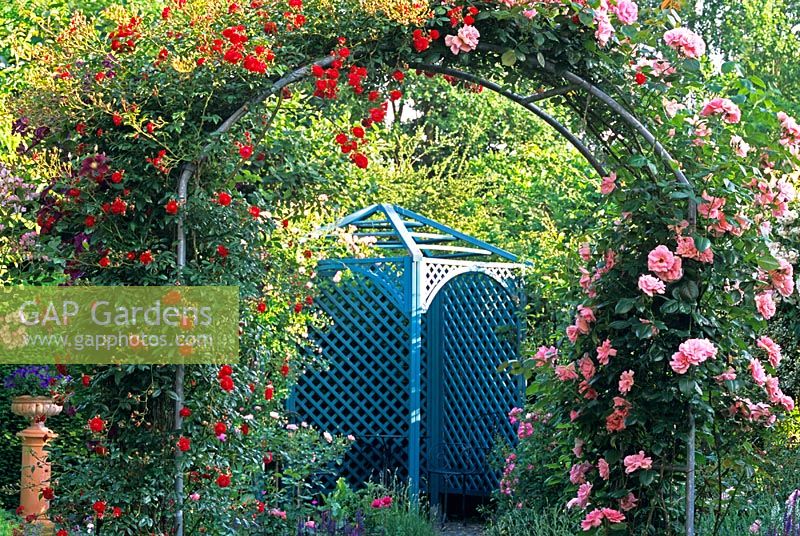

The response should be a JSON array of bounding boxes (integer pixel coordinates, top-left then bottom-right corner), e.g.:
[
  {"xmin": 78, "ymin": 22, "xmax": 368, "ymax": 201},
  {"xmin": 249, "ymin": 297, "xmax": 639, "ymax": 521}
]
[{"xmin": 289, "ymin": 204, "xmax": 523, "ymax": 502}]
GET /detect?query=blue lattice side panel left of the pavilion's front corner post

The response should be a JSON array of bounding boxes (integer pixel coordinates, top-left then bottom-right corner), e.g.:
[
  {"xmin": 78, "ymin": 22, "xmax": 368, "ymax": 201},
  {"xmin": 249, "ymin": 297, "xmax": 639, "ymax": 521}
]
[{"xmin": 290, "ymin": 262, "xmax": 410, "ymax": 485}]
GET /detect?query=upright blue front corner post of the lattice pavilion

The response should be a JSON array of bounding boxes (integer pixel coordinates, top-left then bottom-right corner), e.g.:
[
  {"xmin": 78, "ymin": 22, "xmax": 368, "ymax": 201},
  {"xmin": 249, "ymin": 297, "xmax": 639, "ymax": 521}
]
[{"xmin": 408, "ymin": 256, "xmax": 425, "ymax": 503}]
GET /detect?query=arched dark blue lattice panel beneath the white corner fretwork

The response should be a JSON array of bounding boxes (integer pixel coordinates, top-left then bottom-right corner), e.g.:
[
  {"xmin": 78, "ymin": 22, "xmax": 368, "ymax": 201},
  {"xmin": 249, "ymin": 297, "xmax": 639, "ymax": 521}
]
[{"xmin": 425, "ymin": 272, "xmax": 522, "ymax": 502}]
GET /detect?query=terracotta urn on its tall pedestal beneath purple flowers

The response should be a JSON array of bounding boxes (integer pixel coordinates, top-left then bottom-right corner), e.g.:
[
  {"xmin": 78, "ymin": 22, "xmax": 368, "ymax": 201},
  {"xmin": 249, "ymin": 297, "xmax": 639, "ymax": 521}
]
[{"xmin": 11, "ymin": 396, "xmax": 63, "ymax": 535}]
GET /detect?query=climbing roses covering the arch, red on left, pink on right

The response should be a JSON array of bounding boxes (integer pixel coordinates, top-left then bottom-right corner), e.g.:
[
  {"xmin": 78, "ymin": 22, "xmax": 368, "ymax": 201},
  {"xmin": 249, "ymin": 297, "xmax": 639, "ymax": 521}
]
[{"xmin": 6, "ymin": 0, "xmax": 800, "ymax": 533}]
